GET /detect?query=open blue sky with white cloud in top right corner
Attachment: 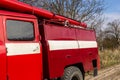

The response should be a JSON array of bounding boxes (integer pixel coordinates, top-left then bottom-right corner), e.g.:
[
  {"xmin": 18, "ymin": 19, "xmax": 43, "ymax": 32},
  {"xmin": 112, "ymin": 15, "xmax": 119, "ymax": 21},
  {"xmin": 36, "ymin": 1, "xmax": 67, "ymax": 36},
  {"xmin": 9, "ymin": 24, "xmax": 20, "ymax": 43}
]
[{"xmin": 104, "ymin": 0, "xmax": 120, "ymax": 22}]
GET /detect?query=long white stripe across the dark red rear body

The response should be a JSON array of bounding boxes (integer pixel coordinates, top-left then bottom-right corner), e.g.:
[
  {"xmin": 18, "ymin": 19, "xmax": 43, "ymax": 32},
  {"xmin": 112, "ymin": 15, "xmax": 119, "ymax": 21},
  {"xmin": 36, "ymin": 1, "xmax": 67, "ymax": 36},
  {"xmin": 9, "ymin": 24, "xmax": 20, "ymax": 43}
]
[{"xmin": 48, "ymin": 40, "xmax": 97, "ymax": 50}]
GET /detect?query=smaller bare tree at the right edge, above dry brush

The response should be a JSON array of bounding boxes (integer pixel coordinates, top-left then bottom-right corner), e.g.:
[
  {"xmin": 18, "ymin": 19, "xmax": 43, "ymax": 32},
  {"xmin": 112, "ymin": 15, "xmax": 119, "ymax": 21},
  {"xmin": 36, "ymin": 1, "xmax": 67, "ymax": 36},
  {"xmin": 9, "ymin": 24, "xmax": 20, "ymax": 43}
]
[{"xmin": 105, "ymin": 19, "xmax": 120, "ymax": 47}]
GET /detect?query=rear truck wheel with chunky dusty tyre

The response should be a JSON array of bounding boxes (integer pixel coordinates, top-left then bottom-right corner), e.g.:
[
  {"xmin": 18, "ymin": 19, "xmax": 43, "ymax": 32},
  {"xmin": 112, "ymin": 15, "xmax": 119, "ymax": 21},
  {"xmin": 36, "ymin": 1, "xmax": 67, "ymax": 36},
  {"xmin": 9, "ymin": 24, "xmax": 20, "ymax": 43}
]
[{"xmin": 61, "ymin": 66, "xmax": 83, "ymax": 80}]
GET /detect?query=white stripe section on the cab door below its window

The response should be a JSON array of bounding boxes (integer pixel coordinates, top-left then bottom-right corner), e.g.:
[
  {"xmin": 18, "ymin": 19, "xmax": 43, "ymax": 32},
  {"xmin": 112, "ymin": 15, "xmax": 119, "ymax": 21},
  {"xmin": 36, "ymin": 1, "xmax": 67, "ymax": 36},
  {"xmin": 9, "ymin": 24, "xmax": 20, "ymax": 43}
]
[{"xmin": 6, "ymin": 43, "xmax": 40, "ymax": 56}]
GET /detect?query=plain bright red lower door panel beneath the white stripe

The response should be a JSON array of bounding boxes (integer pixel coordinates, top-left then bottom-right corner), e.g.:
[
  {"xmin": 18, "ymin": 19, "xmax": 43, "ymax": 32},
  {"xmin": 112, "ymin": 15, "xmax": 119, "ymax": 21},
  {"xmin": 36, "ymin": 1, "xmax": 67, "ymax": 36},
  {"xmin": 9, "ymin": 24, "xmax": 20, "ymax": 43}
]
[{"xmin": 7, "ymin": 54, "xmax": 42, "ymax": 80}]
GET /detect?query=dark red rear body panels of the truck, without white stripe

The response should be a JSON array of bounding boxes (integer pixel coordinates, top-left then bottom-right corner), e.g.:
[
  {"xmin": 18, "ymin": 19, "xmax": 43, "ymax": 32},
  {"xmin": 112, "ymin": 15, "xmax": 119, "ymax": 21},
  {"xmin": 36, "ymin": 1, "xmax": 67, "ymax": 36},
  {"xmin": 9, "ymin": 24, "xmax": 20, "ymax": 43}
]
[{"xmin": 41, "ymin": 24, "xmax": 100, "ymax": 79}]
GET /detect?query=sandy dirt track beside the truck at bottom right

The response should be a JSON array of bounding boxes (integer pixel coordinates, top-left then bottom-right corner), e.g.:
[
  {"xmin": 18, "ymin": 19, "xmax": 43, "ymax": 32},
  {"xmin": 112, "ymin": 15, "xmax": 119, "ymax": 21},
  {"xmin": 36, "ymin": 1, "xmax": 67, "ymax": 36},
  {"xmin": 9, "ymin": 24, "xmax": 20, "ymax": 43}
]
[{"xmin": 85, "ymin": 64, "xmax": 120, "ymax": 80}]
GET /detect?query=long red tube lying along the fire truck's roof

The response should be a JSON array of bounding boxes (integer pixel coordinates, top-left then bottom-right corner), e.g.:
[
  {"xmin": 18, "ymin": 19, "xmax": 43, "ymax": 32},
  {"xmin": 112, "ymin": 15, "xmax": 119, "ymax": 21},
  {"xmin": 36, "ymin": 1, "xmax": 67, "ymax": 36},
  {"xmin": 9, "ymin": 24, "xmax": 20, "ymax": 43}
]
[{"xmin": 0, "ymin": 0, "xmax": 87, "ymax": 28}]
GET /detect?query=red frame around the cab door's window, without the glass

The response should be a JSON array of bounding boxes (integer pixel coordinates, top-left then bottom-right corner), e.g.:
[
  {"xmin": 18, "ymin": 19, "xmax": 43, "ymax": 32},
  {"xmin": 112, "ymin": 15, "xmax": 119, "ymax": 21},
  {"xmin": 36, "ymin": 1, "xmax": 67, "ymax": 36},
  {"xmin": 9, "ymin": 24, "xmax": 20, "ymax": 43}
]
[{"xmin": 3, "ymin": 16, "xmax": 39, "ymax": 43}]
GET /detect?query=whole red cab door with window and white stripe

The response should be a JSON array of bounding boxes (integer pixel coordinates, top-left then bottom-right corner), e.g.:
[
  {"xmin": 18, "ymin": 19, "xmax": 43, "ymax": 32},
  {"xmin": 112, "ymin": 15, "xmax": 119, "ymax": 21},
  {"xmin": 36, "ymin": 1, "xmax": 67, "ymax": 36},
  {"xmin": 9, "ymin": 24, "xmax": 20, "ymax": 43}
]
[{"xmin": 3, "ymin": 16, "xmax": 42, "ymax": 80}]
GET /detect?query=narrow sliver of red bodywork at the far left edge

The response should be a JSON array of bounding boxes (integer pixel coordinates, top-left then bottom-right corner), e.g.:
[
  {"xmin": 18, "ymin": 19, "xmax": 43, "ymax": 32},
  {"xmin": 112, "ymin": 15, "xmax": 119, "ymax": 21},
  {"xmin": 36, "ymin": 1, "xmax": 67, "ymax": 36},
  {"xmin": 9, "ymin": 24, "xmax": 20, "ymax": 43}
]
[{"xmin": 0, "ymin": 16, "xmax": 7, "ymax": 80}]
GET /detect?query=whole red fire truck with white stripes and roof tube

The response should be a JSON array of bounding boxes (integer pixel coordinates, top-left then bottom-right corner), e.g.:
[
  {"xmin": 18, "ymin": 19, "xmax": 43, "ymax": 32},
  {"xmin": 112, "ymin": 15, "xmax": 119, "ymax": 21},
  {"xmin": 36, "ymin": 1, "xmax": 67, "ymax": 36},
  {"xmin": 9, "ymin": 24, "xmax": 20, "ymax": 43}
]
[{"xmin": 0, "ymin": 0, "xmax": 100, "ymax": 80}]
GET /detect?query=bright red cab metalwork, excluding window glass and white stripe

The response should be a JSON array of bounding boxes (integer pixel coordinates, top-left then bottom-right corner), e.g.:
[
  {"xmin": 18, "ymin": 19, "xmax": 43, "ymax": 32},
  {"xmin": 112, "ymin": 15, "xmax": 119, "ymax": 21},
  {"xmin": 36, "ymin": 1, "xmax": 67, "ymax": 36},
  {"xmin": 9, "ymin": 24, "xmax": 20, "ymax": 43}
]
[{"xmin": 0, "ymin": 14, "xmax": 43, "ymax": 80}]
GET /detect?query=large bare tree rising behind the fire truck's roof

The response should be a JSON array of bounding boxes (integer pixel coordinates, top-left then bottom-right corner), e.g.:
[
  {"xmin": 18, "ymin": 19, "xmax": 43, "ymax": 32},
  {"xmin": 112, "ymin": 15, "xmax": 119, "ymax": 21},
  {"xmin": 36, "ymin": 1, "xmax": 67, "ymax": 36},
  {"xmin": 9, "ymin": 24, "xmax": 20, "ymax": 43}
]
[{"xmin": 20, "ymin": 0, "xmax": 104, "ymax": 28}]
